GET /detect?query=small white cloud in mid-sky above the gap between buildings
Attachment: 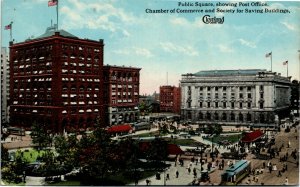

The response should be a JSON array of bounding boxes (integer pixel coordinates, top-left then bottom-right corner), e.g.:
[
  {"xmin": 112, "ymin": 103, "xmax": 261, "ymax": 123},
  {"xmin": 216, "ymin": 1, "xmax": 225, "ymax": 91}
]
[{"xmin": 160, "ymin": 42, "xmax": 199, "ymax": 56}]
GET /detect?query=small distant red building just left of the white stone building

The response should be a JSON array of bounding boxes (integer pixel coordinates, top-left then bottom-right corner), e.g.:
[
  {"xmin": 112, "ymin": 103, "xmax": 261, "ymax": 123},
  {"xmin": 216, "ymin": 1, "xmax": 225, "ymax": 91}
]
[{"xmin": 159, "ymin": 86, "xmax": 181, "ymax": 114}]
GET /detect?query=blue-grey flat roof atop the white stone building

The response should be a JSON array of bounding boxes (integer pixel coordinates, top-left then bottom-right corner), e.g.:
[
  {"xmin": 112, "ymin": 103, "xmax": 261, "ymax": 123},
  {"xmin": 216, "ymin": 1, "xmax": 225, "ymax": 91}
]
[{"xmin": 194, "ymin": 69, "xmax": 266, "ymax": 76}]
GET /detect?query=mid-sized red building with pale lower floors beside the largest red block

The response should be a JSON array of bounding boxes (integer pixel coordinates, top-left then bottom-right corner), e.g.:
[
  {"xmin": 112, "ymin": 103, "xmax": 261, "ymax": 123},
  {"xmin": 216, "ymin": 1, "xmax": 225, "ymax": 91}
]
[{"xmin": 104, "ymin": 65, "xmax": 141, "ymax": 125}]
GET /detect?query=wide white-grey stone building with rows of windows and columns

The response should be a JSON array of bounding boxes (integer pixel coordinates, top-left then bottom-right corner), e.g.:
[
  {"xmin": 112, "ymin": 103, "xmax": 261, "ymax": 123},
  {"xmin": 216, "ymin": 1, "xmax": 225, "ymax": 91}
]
[{"xmin": 180, "ymin": 69, "xmax": 291, "ymax": 126}]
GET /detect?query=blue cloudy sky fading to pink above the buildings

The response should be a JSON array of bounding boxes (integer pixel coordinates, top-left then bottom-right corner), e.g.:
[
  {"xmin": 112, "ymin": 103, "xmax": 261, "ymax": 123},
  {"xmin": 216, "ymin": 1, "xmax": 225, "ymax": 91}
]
[{"xmin": 1, "ymin": 0, "xmax": 300, "ymax": 95}]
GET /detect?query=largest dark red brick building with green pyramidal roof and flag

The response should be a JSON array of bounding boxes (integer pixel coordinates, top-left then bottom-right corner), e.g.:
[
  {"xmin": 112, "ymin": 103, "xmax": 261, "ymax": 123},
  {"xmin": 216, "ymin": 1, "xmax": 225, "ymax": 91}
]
[{"xmin": 10, "ymin": 26, "xmax": 104, "ymax": 132}]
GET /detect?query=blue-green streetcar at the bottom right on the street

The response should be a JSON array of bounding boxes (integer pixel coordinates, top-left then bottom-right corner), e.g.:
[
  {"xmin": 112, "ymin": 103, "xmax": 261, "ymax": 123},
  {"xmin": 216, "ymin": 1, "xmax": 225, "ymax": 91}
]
[{"xmin": 220, "ymin": 160, "xmax": 251, "ymax": 185}]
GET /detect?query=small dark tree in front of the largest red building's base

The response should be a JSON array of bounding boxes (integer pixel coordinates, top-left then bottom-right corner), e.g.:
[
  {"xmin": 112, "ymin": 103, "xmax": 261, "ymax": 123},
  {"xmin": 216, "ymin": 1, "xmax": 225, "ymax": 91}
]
[{"xmin": 30, "ymin": 122, "xmax": 52, "ymax": 151}]
